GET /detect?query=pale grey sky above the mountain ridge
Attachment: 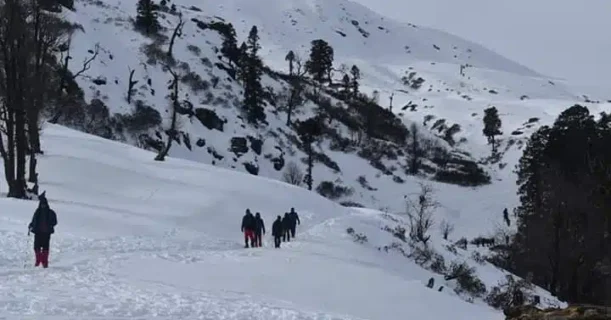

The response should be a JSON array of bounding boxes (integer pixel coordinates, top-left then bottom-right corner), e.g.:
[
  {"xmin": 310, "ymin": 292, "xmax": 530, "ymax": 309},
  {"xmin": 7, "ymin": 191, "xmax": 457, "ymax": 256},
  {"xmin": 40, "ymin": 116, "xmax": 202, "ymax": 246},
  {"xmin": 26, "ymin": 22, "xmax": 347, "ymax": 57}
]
[{"xmin": 352, "ymin": 0, "xmax": 611, "ymax": 87}]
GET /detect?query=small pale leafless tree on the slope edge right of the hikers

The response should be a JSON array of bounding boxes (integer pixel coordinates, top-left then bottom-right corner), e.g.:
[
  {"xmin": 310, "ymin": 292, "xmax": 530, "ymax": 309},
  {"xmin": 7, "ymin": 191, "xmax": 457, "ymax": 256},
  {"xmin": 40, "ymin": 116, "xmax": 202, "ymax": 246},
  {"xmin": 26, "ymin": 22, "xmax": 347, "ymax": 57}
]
[{"xmin": 406, "ymin": 183, "xmax": 439, "ymax": 245}]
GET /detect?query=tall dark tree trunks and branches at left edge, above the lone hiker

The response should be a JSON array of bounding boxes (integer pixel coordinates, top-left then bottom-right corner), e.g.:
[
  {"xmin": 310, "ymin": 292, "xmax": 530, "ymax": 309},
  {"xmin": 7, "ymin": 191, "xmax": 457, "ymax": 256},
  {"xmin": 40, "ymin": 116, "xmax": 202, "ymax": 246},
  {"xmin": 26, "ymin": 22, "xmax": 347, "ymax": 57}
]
[{"xmin": 0, "ymin": 0, "xmax": 75, "ymax": 198}]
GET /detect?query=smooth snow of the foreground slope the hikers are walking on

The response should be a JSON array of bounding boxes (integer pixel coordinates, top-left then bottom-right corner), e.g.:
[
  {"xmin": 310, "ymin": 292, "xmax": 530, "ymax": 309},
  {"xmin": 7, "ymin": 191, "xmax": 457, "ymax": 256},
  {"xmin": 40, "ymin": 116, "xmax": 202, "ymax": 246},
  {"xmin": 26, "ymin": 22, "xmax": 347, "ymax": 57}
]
[{"xmin": 0, "ymin": 125, "xmax": 560, "ymax": 320}]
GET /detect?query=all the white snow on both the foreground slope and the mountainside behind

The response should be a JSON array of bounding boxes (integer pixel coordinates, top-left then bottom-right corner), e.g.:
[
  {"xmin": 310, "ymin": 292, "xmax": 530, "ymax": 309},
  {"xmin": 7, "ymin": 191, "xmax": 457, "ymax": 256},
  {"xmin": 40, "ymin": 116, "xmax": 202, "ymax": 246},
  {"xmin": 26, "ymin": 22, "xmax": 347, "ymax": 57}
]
[{"xmin": 0, "ymin": 0, "xmax": 596, "ymax": 320}]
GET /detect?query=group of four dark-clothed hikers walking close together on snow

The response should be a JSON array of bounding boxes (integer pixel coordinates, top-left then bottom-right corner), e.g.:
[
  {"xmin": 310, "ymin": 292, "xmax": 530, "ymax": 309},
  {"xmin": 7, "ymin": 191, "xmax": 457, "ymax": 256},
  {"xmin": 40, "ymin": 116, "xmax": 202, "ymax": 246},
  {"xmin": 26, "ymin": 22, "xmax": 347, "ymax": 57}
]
[{"xmin": 242, "ymin": 208, "xmax": 301, "ymax": 248}]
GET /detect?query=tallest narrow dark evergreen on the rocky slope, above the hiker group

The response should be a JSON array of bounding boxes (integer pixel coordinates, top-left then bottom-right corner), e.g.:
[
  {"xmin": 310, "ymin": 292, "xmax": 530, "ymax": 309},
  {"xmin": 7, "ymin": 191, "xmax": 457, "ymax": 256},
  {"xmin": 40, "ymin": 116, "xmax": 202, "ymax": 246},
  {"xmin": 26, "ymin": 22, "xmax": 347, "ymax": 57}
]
[{"xmin": 240, "ymin": 26, "xmax": 265, "ymax": 124}]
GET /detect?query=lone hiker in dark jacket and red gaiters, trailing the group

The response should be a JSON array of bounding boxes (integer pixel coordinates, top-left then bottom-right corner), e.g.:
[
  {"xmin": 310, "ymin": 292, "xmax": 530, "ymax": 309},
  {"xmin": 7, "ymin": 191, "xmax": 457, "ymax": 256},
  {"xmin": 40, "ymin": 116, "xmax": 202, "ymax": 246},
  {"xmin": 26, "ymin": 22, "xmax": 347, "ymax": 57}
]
[{"xmin": 28, "ymin": 191, "xmax": 57, "ymax": 268}]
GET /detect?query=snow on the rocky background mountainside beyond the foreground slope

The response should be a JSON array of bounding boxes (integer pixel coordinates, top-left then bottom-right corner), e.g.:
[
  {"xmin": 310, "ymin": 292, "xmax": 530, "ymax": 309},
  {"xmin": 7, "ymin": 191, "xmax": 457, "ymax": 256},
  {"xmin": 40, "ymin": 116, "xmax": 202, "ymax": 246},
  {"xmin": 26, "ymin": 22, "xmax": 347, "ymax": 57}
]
[{"xmin": 53, "ymin": 0, "xmax": 604, "ymax": 226}]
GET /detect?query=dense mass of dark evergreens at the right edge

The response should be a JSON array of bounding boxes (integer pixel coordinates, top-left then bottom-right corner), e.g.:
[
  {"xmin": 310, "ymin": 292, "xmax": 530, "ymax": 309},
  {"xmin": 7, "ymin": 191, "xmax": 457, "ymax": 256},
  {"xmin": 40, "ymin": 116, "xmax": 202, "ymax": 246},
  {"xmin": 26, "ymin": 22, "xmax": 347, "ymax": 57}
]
[{"xmin": 506, "ymin": 105, "xmax": 611, "ymax": 304}]
